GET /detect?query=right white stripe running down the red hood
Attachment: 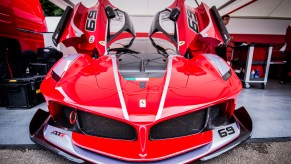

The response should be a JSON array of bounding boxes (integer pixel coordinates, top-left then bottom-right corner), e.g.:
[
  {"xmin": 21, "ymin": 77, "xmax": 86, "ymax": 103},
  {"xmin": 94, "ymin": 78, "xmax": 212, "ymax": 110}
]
[{"xmin": 156, "ymin": 56, "xmax": 173, "ymax": 120}]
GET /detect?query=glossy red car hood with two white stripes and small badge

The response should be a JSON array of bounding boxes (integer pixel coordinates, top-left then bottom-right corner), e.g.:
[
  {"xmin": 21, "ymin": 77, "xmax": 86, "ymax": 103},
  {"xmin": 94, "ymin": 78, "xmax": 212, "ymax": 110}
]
[{"xmin": 41, "ymin": 55, "xmax": 241, "ymax": 122}]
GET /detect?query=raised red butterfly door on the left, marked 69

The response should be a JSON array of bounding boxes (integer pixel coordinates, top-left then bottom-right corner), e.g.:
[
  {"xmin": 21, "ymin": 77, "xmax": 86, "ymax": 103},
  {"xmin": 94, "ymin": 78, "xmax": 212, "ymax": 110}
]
[{"xmin": 52, "ymin": 0, "xmax": 135, "ymax": 57}]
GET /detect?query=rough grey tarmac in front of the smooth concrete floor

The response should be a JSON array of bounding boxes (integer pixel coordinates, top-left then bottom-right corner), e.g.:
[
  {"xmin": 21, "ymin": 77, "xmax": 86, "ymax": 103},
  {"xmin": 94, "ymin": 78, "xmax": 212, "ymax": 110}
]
[{"xmin": 0, "ymin": 140, "xmax": 291, "ymax": 164}]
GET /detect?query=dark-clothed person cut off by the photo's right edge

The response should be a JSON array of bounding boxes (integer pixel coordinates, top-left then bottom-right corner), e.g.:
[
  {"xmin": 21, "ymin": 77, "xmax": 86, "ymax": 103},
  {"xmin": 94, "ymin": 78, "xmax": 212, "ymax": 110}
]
[{"xmin": 280, "ymin": 24, "xmax": 291, "ymax": 84}]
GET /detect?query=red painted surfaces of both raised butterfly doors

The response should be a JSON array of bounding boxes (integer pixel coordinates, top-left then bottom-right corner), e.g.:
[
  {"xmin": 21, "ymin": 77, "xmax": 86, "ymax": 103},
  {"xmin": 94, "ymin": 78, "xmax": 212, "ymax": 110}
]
[{"xmin": 60, "ymin": 0, "xmax": 223, "ymax": 56}]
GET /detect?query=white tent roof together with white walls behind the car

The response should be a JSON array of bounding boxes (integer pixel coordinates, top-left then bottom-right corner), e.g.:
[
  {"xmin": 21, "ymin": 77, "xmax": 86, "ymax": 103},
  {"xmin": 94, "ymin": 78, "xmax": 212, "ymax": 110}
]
[{"xmin": 46, "ymin": 0, "xmax": 291, "ymax": 35}]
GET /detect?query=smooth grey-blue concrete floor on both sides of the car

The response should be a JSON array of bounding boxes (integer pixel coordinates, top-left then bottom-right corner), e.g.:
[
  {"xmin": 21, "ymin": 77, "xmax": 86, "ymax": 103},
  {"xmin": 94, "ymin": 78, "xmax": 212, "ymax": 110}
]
[{"xmin": 0, "ymin": 80, "xmax": 291, "ymax": 147}]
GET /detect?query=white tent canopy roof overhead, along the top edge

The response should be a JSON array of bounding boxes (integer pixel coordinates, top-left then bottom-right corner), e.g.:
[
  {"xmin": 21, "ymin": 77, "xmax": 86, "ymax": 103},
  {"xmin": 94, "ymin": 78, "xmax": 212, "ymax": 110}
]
[{"xmin": 50, "ymin": 0, "xmax": 291, "ymax": 19}]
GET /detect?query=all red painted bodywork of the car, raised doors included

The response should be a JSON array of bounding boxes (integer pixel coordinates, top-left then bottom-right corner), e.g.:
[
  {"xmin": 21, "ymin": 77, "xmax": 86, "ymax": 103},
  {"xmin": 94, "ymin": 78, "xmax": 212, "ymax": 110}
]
[{"xmin": 30, "ymin": 0, "xmax": 252, "ymax": 162}]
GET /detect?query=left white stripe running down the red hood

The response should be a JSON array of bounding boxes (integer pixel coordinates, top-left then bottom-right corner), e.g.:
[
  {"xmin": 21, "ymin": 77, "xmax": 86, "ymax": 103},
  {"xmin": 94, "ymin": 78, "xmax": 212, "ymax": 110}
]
[{"xmin": 111, "ymin": 55, "xmax": 129, "ymax": 120}]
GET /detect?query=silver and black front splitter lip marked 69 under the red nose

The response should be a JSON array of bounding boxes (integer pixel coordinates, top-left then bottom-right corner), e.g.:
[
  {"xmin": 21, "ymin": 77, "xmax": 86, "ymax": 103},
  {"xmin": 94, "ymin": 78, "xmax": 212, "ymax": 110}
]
[{"xmin": 29, "ymin": 107, "xmax": 252, "ymax": 163}]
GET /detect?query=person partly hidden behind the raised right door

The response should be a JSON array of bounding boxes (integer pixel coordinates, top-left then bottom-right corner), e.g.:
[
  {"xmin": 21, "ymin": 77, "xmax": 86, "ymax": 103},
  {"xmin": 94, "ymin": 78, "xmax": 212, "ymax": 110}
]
[{"xmin": 215, "ymin": 14, "xmax": 234, "ymax": 63}]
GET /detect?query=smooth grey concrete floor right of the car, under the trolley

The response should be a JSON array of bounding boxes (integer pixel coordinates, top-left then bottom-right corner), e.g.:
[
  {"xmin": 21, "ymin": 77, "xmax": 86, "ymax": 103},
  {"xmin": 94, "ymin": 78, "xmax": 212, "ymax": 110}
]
[{"xmin": 237, "ymin": 80, "xmax": 291, "ymax": 138}]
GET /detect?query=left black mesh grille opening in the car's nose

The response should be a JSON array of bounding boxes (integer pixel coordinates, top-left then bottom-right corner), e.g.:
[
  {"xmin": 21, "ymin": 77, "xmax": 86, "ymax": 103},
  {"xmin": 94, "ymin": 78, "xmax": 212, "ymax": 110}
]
[{"xmin": 78, "ymin": 111, "xmax": 136, "ymax": 140}]
